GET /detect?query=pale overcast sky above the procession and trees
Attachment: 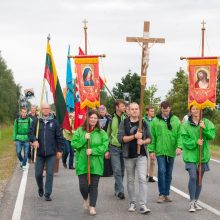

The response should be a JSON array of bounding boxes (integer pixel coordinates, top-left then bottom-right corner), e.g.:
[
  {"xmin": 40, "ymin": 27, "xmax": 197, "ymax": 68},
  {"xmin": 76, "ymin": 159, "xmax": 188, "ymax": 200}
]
[{"xmin": 0, "ymin": 0, "xmax": 220, "ymax": 104}]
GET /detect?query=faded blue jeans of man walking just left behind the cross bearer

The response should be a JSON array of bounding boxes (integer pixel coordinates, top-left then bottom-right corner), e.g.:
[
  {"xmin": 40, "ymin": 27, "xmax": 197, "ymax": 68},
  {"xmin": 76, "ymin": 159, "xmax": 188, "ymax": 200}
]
[{"xmin": 109, "ymin": 145, "xmax": 125, "ymax": 196}]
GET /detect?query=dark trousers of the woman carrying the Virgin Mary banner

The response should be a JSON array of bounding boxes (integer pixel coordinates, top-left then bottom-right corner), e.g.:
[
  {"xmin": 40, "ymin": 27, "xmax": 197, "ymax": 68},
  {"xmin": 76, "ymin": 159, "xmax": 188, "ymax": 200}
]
[{"xmin": 78, "ymin": 174, "xmax": 100, "ymax": 207}]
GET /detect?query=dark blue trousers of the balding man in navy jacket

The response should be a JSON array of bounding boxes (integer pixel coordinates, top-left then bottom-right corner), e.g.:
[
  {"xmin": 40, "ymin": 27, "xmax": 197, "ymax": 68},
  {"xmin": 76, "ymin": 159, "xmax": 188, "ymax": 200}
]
[{"xmin": 35, "ymin": 155, "xmax": 55, "ymax": 196}]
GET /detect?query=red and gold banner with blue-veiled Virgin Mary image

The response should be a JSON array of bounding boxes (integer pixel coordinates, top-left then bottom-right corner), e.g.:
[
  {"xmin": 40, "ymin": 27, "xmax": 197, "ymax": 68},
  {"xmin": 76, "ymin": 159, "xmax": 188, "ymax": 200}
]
[{"xmin": 74, "ymin": 56, "xmax": 102, "ymax": 108}]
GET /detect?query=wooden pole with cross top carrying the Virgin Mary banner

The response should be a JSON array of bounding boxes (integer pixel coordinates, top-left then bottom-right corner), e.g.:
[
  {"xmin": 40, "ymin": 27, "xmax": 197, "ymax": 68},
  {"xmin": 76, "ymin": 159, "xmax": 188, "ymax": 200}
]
[{"xmin": 83, "ymin": 19, "xmax": 91, "ymax": 185}]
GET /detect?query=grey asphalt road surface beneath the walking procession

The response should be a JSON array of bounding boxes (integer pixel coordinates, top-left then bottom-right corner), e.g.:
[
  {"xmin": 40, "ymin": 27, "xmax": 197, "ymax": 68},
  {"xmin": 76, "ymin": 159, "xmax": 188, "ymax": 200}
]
[{"xmin": 0, "ymin": 158, "xmax": 220, "ymax": 220}]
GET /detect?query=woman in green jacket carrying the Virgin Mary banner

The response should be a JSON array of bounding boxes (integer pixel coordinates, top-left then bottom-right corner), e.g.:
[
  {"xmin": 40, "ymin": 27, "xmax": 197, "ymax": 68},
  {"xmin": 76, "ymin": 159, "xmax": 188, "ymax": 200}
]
[{"xmin": 71, "ymin": 110, "xmax": 109, "ymax": 215}]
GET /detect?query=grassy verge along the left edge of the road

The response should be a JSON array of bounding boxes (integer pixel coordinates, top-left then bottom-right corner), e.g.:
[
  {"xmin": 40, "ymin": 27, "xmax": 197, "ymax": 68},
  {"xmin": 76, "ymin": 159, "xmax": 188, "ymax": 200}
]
[{"xmin": 0, "ymin": 127, "xmax": 17, "ymax": 198}]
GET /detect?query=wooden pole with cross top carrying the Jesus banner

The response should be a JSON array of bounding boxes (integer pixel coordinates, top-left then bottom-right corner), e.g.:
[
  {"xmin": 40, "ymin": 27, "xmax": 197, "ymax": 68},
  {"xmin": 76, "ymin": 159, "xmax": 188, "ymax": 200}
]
[{"xmin": 198, "ymin": 21, "xmax": 205, "ymax": 186}]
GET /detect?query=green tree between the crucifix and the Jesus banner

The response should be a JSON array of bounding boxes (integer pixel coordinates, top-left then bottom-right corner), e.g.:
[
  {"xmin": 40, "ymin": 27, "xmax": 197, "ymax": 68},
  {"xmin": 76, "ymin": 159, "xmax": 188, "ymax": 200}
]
[{"xmin": 166, "ymin": 69, "xmax": 188, "ymax": 118}]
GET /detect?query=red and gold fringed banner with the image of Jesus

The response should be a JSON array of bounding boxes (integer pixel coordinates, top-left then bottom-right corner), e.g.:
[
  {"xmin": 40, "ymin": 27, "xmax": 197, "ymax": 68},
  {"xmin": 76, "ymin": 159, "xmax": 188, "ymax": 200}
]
[{"xmin": 188, "ymin": 57, "xmax": 218, "ymax": 109}]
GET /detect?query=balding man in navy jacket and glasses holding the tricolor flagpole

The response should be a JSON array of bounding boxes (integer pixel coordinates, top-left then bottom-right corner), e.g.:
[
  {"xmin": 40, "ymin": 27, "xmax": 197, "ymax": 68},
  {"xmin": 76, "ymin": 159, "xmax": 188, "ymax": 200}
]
[{"xmin": 29, "ymin": 103, "xmax": 64, "ymax": 201}]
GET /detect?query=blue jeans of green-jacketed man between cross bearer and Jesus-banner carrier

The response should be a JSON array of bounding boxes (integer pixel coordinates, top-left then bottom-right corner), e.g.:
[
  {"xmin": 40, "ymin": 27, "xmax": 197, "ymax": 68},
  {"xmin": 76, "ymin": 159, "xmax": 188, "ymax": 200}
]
[{"xmin": 157, "ymin": 156, "xmax": 174, "ymax": 196}]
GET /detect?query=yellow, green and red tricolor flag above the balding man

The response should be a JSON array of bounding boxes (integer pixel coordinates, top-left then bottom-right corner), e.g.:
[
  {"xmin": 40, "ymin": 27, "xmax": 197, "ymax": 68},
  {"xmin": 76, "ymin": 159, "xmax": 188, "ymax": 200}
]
[{"xmin": 44, "ymin": 42, "xmax": 72, "ymax": 131}]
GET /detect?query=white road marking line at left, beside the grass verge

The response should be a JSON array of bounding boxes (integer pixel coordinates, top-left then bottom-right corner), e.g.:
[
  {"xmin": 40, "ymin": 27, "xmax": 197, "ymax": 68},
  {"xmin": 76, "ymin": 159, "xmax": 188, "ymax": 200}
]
[{"xmin": 12, "ymin": 164, "xmax": 29, "ymax": 220}]
